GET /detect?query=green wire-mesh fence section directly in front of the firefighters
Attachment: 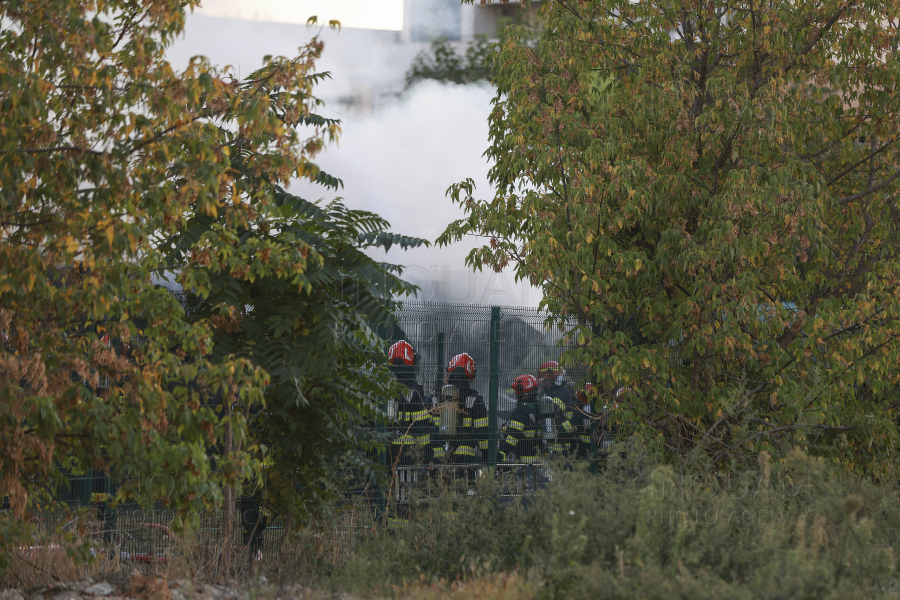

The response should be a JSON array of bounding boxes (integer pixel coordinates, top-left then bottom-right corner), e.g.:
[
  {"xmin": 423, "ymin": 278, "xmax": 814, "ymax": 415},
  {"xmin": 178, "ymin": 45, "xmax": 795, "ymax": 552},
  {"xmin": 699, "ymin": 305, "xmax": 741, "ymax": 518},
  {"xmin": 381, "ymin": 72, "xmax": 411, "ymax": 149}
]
[{"xmin": 369, "ymin": 301, "xmax": 637, "ymax": 520}]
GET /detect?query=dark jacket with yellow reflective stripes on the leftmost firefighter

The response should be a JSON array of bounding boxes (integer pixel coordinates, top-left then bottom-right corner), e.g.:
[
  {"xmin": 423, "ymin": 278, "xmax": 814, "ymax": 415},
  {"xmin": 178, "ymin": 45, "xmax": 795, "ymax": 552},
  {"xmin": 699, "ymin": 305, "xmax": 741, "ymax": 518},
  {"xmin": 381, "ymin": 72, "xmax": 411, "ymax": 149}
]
[{"xmin": 389, "ymin": 378, "xmax": 434, "ymax": 465}]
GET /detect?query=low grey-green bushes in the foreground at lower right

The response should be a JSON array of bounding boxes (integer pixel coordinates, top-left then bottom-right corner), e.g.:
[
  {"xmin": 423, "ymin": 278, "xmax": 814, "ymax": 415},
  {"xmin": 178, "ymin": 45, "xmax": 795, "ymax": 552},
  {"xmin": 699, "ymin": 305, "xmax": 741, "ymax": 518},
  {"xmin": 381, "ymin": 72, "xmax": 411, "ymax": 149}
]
[{"xmin": 335, "ymin": 451, "xmax": 900, "ymax": 598}]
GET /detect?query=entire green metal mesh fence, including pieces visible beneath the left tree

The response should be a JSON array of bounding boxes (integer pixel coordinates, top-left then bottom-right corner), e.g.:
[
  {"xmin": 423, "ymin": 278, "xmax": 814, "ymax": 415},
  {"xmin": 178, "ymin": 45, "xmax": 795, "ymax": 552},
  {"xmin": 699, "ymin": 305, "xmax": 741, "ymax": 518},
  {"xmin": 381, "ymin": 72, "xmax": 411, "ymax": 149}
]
[{"xmin": 10, "ymin": 301, "xmax": 636, "ymax": 564}]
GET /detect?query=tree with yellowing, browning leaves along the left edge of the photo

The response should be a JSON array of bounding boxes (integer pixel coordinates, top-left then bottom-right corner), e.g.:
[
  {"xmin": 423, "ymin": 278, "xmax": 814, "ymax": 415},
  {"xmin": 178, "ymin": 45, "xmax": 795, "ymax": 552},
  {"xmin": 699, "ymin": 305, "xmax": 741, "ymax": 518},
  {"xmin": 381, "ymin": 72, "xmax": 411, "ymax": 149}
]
[{"xmin": 0, "ymin": 0, "xmax": 412, "ymax": 562}]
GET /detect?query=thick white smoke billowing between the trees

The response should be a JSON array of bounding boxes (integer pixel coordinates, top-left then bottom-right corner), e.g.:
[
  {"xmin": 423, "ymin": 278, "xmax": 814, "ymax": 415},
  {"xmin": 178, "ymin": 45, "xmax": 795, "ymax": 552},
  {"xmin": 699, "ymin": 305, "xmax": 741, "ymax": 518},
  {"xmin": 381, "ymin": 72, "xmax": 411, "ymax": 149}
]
[{"xmin": 168, "ymin": 7, "xmax": 541, "ymax": 306}]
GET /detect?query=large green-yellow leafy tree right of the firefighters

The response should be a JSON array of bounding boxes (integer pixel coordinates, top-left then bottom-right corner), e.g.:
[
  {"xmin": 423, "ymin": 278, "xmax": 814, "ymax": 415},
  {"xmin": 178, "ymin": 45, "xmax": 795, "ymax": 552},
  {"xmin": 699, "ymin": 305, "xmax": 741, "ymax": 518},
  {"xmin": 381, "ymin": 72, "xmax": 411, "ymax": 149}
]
[{"xmin": 439, "ymin": 0, "xmax": 900, "ymax": 476}]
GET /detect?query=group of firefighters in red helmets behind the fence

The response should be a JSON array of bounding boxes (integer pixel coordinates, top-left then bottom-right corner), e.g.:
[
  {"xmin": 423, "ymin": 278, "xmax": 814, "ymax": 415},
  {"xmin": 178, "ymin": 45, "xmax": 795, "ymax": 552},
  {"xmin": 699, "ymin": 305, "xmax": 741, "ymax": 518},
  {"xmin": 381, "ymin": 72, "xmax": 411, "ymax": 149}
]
[{"xmin": 387, "ymin": 340, "xmax": 616, "ymax": 467}]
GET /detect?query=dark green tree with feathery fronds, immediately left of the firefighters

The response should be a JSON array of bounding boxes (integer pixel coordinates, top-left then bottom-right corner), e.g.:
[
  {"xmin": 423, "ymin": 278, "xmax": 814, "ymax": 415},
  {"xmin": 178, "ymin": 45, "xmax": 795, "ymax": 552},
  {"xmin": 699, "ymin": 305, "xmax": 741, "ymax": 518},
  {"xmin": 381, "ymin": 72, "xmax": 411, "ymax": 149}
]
[{"xmin": 168, "ymin": 182, "xmax": 428, "ymax": 519}]
